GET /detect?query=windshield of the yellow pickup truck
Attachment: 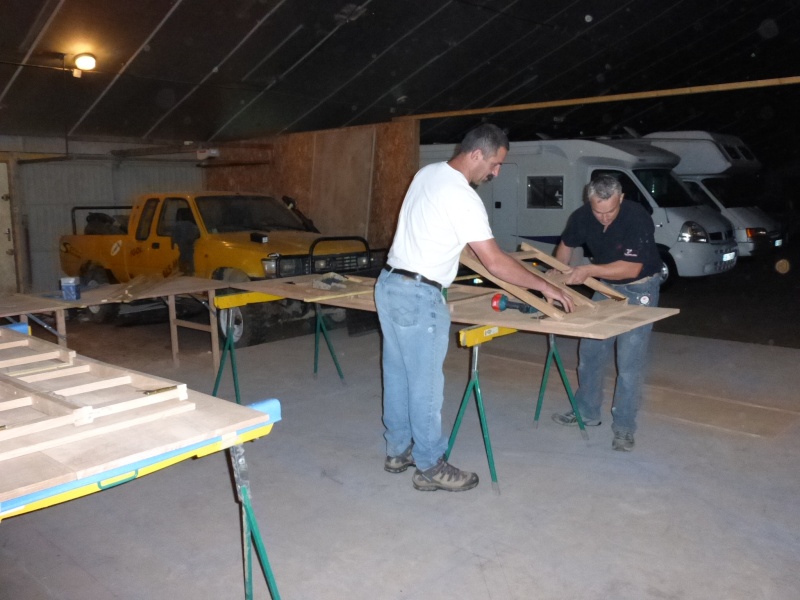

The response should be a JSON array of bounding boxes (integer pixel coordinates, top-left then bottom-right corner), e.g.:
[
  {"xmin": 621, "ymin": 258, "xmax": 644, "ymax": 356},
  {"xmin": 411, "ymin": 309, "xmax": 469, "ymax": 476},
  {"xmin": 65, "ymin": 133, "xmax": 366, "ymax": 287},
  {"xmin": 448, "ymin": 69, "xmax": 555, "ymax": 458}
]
[{"xmin": 197, "ymin": 196, "xmax": 306, "ymax": 233}]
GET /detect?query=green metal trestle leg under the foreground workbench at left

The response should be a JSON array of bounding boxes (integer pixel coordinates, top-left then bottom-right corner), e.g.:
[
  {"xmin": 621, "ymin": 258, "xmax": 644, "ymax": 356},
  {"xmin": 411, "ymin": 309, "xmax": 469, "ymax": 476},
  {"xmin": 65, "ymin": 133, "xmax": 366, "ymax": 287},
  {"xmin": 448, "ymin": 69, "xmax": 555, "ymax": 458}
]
[{"xmin": 229, "ymin": 445, "xmax": 281, "ymax": 600}]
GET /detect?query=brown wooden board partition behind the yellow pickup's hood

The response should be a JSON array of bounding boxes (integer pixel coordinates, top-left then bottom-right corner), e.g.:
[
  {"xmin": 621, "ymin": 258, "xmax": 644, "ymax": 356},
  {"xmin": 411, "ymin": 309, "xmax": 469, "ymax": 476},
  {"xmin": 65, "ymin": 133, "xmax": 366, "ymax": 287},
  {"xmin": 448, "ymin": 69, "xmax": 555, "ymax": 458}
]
[{"xmin": 206, "ymin": 121, "xmax": 419, "ymax": 248}]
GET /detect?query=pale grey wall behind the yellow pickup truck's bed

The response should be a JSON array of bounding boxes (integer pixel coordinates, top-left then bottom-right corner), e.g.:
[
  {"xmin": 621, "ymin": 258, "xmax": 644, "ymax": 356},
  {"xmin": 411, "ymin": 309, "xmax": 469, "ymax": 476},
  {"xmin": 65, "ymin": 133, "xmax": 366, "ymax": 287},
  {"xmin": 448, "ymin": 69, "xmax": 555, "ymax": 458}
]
[{"xmin": 19, "ymin": 159, "xmax": 204, "ymax": 292}]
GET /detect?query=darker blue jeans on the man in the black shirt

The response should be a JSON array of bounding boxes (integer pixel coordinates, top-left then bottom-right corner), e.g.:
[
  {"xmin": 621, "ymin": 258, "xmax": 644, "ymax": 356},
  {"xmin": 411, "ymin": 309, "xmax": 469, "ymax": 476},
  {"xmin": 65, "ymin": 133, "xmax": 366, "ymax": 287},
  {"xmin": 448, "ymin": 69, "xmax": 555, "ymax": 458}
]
[{"xmin": 575, "ymin": 276, "xmax": 659, "ymax": 434}]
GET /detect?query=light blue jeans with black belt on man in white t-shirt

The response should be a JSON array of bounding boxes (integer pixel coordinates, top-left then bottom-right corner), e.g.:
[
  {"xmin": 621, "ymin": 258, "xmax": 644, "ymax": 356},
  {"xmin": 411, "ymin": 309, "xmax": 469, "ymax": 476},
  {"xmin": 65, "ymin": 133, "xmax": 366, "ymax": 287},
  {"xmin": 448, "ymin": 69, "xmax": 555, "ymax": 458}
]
[{"xmin": 375, "ymin": 271, "xmax": 450, "ymax": 471}]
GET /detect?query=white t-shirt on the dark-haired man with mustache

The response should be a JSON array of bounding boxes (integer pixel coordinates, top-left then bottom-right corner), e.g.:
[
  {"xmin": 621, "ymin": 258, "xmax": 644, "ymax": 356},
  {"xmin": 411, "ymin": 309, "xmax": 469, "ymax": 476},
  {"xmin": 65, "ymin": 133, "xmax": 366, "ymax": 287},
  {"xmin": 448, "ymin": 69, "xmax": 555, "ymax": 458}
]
[{"xmin": 387, "ymin": 162, "xmax": 494, "ymax": 287}]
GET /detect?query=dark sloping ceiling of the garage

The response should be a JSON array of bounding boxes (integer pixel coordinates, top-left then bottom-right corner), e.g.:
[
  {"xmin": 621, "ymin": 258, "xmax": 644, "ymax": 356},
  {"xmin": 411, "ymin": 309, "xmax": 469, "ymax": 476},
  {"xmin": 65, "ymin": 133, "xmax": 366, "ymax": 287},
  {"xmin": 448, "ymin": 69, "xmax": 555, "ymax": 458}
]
[{"xmin": 0, "ymin": 0, "xmax": 800, "ymax": 163}]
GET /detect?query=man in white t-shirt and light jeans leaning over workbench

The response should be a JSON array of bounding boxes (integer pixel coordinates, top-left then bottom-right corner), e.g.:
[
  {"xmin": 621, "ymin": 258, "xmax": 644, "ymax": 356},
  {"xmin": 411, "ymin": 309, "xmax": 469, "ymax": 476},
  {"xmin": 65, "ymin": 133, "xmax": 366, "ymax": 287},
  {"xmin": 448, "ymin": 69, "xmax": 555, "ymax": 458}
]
[{"xmin": 375, "ymin": 124, "xmax": 572, "ymax": 492}]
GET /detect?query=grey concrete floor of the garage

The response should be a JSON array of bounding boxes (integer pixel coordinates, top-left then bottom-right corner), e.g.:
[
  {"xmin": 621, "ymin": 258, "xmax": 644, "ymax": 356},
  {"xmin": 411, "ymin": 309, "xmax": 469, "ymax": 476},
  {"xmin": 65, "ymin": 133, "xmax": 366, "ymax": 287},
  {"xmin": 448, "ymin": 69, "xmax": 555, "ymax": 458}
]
[{"xmin": 0, "ymin": 323, "xmax": 800, "ymax": 600}]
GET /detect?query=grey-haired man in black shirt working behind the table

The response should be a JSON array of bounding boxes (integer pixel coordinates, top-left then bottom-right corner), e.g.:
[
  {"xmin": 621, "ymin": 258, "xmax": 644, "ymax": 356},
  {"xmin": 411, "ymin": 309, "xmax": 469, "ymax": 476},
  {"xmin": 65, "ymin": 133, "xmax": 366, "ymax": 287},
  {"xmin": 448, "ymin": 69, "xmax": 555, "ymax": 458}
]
[{"xmin": 553, "ymin": 175, "xmax": 661, "ymax": 451}]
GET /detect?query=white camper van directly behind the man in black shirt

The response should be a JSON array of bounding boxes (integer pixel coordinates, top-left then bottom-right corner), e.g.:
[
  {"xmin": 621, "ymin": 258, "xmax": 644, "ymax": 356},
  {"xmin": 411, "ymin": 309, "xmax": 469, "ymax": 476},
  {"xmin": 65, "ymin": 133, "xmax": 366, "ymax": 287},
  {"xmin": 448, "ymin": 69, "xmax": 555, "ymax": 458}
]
[{"xmin": 420, "ymin": 140, "xmax": 737, "ymax": 285}]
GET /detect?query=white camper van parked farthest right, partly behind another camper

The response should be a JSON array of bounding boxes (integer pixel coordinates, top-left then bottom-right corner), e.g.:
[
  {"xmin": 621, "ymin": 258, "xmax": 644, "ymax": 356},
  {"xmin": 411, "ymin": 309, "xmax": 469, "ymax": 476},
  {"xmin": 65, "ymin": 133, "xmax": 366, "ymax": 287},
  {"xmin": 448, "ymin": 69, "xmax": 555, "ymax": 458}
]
[{"xmin": 643, "ymin": 131, "xmax": 786, "ymax": 256}]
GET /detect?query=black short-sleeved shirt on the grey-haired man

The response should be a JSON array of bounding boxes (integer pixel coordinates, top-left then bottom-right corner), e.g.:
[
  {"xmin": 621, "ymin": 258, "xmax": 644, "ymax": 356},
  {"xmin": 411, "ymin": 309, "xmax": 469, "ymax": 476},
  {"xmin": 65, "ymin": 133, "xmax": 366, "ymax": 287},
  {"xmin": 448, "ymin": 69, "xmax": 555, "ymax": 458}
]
[{"xmin": 561, "ymin": 200, "xmax": 661, "ymax": 283}]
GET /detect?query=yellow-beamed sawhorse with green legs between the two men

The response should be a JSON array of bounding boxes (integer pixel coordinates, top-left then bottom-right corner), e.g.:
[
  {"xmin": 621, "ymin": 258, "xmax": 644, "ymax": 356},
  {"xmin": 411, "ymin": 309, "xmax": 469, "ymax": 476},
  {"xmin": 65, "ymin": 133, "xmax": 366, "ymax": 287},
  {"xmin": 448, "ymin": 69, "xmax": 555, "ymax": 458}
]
[{"xmin": 444, "ymin": 325, "xmax": 589, "ymax": 494}]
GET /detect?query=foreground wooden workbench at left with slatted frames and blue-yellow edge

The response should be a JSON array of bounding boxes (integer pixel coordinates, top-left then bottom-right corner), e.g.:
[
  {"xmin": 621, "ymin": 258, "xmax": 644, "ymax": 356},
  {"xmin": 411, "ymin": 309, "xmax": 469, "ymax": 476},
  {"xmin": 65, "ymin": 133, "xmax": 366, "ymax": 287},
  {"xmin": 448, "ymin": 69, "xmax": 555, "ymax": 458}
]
[{"xmin": 0, "ymin": 329, "xmax": 280, "ymax": 519}]
